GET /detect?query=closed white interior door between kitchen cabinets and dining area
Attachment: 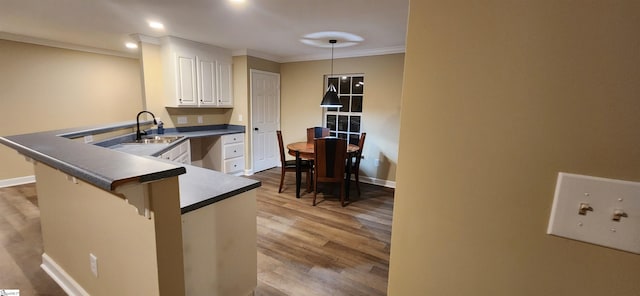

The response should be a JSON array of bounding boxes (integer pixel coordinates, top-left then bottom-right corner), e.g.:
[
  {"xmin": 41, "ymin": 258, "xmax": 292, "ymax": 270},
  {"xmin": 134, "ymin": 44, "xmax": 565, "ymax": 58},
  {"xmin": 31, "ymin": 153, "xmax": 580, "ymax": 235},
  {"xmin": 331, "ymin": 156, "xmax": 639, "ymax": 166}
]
[{"xmin": 251, "ymin": 69, "xmax": 280, "ymax": 172}]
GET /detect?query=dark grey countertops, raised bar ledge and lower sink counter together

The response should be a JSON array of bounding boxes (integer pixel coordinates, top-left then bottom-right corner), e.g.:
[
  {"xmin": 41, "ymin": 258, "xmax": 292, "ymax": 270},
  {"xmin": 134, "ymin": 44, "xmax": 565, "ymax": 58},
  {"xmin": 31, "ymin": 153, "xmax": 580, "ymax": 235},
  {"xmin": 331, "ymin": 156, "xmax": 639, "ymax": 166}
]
[{"xmin": 0, "ymin": 121, "xmax": 260, "ymax": 213}]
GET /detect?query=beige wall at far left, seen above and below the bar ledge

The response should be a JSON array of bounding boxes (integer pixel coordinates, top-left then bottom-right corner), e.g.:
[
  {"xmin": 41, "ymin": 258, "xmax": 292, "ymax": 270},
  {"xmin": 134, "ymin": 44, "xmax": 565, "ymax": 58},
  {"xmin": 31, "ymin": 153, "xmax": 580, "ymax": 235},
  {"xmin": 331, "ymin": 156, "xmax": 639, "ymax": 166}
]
[{"xmin": 0, "ymin": 40, "xmax": 142, "ymax": 180}]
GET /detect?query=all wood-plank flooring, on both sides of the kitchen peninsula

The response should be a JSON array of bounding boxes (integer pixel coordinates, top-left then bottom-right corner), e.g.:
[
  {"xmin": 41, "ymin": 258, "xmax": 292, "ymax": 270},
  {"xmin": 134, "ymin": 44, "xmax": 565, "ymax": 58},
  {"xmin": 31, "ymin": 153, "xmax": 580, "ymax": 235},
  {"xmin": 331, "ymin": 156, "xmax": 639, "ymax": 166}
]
[{"xmin": 0, "ymin": 169, "xmax": 394, "ymax": 296}]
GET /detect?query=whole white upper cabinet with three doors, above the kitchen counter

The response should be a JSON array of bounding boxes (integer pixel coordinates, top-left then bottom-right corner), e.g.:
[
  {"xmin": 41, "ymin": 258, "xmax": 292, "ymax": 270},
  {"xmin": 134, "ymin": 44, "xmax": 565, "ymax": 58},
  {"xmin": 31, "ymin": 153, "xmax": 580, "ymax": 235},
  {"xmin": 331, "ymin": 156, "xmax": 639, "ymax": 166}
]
[{"xmin": 162, "ymin": 37, "xmax": 233, "ymax": 108}]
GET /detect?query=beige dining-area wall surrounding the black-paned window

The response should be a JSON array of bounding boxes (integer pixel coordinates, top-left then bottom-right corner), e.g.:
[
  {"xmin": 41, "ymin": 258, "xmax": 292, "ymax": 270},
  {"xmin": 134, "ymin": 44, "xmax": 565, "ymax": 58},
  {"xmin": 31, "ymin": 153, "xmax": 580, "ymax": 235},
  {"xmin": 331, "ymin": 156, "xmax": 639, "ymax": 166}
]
[{"xmin": 281, "ymin": 54, "xmax": 404, "ymax": 181}]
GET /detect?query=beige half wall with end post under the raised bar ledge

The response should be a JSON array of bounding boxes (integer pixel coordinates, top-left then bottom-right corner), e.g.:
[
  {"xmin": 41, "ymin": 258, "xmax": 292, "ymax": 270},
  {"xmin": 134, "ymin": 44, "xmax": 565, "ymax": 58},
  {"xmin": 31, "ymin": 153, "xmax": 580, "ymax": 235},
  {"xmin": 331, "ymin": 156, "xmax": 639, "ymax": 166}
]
[{"xmin": 35, "ymin": 163, "xmax": 185, "ymax": 295}]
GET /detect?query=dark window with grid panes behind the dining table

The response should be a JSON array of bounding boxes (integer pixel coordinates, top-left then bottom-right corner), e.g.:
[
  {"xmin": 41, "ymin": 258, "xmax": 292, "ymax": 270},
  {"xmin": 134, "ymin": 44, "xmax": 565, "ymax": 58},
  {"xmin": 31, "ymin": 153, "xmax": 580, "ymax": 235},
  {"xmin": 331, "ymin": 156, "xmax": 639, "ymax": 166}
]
[{"xmin": 324, "ymin": 74, "xmax": 364, "ymax": 145}]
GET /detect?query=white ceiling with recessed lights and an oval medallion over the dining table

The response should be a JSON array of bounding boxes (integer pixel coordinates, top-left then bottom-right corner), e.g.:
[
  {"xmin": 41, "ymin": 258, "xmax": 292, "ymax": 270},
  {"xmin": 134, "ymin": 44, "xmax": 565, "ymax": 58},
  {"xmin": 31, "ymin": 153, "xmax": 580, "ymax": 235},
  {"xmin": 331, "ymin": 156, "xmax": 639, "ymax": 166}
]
[{"xmin": 0, "ymin": 0, "xmax": 409, "ymax": 62}]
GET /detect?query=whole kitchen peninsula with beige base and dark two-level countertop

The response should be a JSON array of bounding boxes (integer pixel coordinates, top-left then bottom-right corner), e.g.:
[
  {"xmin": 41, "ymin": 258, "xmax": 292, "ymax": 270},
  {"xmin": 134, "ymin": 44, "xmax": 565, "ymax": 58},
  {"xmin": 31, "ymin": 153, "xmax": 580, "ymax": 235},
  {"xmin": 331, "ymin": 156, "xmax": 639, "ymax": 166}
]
[{"xmin": 0, "ymin": 121, "xmax": 260, "ymax": 295}]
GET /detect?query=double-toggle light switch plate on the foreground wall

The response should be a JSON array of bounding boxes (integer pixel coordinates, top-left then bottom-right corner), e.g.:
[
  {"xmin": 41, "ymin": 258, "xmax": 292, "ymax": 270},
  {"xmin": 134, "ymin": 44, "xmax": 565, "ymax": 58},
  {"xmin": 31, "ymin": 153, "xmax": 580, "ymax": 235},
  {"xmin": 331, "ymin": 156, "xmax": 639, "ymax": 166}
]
[{"xmin": 547, "ymin": 173, "xmax": 640, "ymax": 254}]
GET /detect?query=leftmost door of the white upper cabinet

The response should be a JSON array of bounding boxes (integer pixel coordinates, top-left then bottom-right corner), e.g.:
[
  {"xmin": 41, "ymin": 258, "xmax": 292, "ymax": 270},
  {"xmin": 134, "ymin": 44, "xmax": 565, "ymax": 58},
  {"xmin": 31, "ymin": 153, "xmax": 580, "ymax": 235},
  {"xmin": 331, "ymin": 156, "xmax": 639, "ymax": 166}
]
[{"xmin": 176, "ymin": 54, "xmax": 198, "ymax": 106}]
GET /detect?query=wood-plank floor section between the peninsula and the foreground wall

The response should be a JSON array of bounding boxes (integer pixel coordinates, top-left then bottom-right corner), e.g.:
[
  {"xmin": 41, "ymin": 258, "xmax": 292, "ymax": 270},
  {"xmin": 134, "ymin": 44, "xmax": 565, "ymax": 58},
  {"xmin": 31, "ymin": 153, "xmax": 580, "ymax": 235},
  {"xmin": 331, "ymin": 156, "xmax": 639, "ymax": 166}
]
[{"xmin": 251, "ymin": 169, "xmax": 394, "ymax": 295}]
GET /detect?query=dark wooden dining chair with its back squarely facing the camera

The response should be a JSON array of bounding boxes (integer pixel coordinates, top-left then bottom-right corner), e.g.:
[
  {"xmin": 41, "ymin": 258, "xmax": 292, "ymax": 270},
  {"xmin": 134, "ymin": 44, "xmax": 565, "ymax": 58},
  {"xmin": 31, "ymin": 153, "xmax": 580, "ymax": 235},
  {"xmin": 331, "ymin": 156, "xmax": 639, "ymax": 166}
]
[{"xmin": 313, "ymin": 138, "xmax": 347, "ymax": 207}]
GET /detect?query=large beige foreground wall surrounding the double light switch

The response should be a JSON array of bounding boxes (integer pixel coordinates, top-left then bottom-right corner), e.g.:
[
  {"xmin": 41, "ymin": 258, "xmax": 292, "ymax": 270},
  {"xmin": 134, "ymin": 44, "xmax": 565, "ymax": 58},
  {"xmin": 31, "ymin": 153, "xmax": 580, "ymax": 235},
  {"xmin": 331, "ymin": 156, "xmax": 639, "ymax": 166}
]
[{"xmin": 389, "ymin": 0, "xmax": 640, "ymax": 296}]
